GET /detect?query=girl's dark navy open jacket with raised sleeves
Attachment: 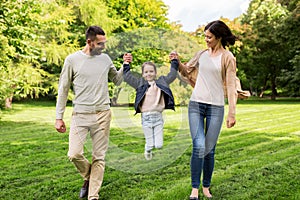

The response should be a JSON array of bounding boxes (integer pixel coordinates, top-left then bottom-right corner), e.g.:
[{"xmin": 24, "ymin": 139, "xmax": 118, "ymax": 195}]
[{"xmin": 123, "ymin": 59, "xmax": 179, "ymax": 114}]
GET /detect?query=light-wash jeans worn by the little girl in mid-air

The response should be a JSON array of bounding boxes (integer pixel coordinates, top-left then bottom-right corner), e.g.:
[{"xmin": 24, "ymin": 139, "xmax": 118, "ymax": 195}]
[{"xmin": 141, "ymin": 111, "xmax": 164, "ymax": 151}]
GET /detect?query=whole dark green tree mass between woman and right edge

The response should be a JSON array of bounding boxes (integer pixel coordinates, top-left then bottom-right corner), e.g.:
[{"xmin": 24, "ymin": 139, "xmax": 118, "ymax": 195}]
[{"xmin": 238, "ymin": 0, "xmax": 300, "ymax": 98}]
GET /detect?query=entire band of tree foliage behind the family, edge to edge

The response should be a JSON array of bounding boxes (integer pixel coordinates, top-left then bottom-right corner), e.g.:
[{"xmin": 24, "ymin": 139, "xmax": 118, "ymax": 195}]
[{"xmin": 0, "ymin": 0, "xmax": 300, "ymax": 110}]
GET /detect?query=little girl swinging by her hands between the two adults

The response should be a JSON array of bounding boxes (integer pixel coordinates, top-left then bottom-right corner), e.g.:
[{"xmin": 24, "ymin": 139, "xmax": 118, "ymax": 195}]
[{"xmin": 123, "ymin": 52, "xmax": 179, "ymax": 160}]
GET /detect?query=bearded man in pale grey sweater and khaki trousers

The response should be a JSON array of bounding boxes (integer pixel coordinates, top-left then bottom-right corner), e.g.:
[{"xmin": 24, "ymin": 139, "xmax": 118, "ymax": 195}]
[{"xmin": 55, "ymin": 26, "xmax": 132, "ymax": 200}]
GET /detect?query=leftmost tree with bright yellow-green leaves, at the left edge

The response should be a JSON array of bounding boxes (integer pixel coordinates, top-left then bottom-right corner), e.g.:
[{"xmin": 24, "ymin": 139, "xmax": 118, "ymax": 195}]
[{"xmin": 0, "ymin": 0, "xmax": 49, "ymax": 107}]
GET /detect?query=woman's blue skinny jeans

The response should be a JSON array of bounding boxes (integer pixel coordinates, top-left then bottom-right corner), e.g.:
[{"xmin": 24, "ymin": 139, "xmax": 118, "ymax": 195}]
[{"xmin": 188, "ymin": 101, "xmax": 224, "ymax": 188}]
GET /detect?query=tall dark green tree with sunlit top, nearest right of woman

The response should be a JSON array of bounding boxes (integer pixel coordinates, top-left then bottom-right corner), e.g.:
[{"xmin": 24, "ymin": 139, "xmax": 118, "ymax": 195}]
[{"xmin": 240, "ymin": 0, "xmax": 288, "ymax": 99}]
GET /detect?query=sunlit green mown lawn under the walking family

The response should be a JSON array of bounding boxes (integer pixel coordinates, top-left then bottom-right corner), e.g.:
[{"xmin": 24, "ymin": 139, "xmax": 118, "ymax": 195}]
[{"xmin": 0, "ymin": 99, "xmax": 300, "ymax": 200}]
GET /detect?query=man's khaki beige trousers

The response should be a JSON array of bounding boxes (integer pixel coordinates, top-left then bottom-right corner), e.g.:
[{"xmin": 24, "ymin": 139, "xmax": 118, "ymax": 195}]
[{"xmin": 68, "ymin": 110, "xmax": 111, "ymax": 200}]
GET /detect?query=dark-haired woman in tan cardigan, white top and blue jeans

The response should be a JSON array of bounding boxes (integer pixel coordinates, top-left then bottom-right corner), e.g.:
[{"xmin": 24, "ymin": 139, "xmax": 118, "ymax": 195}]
[{"xmin": 179, "ymin": 20, "xmax": 237, "ymax": 200}]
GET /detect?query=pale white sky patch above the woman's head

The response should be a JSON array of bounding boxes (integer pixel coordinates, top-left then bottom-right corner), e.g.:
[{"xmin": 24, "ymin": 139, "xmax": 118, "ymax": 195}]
[{"xmin": 163, "ymin": 0, "xmax": 250, "ymax": 32}]
